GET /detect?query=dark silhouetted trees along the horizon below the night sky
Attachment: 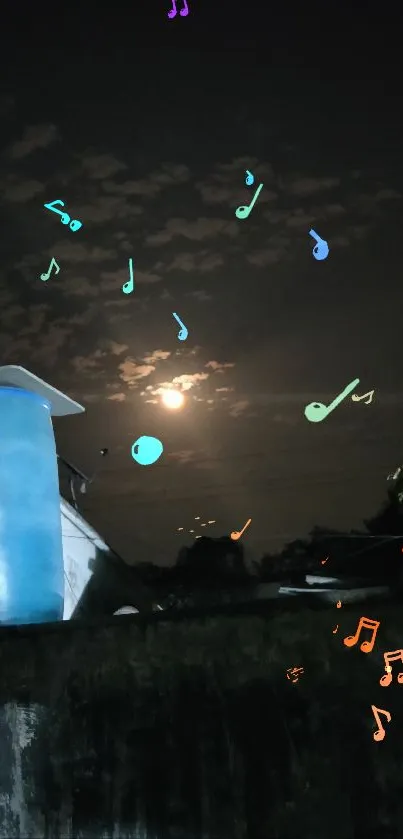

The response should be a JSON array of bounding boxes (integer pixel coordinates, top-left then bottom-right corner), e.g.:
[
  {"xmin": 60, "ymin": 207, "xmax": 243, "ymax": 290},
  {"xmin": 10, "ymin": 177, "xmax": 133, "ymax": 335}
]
[{"xmin": 136, "ymin": 467, "xmax": 403, "ymax": 608}]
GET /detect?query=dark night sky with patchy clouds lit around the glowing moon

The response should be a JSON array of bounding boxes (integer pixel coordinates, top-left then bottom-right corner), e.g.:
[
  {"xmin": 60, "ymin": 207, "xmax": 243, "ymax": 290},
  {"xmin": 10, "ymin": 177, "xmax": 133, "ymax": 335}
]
[{"xmin": 0, "ymin": 0, "xmax": 403, "ymax": 564}]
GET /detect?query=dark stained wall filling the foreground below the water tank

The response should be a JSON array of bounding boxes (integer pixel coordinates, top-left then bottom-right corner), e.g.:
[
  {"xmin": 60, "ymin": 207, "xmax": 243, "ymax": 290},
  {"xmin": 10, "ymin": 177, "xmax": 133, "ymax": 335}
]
[{"xmin": 0, "ymin": 602, "xmax": 403, "ymax": 839}]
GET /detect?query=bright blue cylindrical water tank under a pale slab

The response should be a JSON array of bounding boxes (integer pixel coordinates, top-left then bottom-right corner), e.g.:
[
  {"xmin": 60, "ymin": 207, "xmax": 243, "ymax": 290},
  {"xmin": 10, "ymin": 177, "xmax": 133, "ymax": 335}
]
[{"xmin": 0, "ymin": 386, "xmax": 64, "ymax": 624}]
